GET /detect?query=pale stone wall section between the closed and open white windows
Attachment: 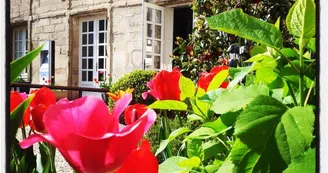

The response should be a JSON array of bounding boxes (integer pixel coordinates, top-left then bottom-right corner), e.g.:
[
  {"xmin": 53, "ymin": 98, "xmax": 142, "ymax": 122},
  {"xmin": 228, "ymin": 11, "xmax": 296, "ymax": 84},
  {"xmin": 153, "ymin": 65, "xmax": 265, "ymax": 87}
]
[{"xmin": 111, "ymin": 5, "xmax": 142, "ymax": 81}]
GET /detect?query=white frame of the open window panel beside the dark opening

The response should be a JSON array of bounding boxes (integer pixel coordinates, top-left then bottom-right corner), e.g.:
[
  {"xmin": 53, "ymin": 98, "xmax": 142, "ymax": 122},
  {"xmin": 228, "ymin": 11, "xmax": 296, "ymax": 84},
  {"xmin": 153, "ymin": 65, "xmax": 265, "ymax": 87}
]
[{"xmin": 142, "ymin": 2, "xmax": 165, "ymax": 70}]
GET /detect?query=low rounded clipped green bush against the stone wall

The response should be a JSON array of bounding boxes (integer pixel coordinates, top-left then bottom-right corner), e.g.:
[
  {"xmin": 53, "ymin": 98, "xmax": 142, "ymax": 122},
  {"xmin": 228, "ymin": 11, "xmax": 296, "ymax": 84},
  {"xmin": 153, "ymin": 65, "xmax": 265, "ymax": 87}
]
[{"xmin": 109, "ymin": 70, "xmax": 155, "ymax": 105}]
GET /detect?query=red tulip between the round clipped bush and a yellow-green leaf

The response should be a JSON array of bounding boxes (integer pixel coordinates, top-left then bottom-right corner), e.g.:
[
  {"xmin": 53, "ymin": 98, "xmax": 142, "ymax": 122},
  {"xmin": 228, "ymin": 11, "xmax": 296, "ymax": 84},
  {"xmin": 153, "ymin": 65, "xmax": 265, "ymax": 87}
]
[{"xmin": 142, "ymin": 68, "xmax": 181, "ymax": 100}]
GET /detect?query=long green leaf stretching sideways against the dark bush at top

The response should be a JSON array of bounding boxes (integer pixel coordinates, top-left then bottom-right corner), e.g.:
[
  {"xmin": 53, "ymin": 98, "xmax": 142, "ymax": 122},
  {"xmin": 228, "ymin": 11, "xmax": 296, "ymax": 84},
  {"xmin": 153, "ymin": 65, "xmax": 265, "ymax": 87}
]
[{"xmin": 206, "ymin": 9, "xmax": 283, "ymax": 48}]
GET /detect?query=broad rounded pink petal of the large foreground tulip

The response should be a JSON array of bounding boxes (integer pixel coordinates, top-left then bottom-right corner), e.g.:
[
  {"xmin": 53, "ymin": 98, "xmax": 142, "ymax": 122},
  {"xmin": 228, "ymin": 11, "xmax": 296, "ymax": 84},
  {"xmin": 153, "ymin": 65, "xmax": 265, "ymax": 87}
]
[{"xmin": 43, "ymin": 97, "xmax": 113, "ymax": 141}]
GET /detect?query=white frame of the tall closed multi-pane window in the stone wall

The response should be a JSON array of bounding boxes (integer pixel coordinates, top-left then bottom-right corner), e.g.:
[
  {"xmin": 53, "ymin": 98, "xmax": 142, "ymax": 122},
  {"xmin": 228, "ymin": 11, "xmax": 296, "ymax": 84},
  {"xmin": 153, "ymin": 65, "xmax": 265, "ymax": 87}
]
[{"xmin": 79, "ymin": 15, "xmax": 109, "ymax": 88}]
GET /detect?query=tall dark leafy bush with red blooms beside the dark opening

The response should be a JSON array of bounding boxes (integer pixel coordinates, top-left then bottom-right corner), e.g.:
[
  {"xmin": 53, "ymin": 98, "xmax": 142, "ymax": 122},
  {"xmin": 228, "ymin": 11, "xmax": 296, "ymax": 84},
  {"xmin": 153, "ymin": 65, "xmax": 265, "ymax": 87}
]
[{"xmin": 172, "ymin": 0, "xmax": 294, "ymax": 82}]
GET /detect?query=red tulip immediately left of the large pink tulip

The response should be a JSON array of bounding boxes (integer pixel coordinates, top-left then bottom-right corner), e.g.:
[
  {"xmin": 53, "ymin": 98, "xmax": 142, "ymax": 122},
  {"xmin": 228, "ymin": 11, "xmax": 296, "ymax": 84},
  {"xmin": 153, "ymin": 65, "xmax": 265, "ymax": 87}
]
[{"xmin": 30, "ymin": 87, "xmax": 57, "ymax": 133}]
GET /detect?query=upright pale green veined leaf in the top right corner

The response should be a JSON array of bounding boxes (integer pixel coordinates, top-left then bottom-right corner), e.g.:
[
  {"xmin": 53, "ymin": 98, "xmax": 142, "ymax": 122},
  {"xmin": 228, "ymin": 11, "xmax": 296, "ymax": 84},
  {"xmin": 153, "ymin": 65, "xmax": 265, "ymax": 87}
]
[{"xmin": 286, "ymin": 0, "xmax": 316, "ymax": 39}]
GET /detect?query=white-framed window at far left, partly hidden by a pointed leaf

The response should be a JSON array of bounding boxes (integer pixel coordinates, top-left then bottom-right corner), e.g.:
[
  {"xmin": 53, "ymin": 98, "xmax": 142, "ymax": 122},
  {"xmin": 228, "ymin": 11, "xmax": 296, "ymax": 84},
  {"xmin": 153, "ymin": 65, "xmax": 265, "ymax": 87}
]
[{"xmin": 12, "ymin": 26, "xmax": 28, "ymax": 80}]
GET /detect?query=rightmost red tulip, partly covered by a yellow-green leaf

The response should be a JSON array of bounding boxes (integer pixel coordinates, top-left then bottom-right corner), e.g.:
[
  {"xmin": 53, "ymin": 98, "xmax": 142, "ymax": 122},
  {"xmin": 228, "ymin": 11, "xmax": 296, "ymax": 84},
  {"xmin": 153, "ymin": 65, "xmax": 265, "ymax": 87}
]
[{"xmin": 198, "ymin": 65, "xmax": 229, "ymax": 91}]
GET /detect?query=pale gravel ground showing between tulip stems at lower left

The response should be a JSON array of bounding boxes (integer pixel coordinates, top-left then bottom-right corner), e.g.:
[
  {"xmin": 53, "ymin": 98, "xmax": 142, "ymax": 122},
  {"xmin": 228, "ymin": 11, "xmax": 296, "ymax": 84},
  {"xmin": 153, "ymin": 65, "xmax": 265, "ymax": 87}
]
[{"xmin": 16, "ymin": 127, "xmax": 73, "ymax": 173}]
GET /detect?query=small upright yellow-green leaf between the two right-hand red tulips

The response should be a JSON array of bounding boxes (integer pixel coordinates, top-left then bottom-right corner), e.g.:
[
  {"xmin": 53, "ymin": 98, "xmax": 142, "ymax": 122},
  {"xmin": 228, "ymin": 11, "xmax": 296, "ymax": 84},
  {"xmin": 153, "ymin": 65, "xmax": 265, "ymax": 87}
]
[{"xmin": 179, "ymin": 76, "xmax": 196, "ymax": 100}]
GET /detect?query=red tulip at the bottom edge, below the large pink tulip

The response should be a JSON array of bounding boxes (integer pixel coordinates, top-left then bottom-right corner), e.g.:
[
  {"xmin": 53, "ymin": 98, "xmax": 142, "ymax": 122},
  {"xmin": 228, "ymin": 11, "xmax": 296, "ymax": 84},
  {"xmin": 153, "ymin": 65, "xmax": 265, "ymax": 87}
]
[{"xmin": 115, "ymin": 140, "xmax": 158, "ymax": 173}]
